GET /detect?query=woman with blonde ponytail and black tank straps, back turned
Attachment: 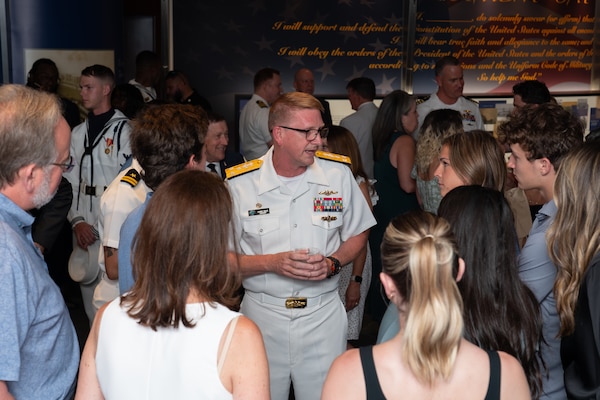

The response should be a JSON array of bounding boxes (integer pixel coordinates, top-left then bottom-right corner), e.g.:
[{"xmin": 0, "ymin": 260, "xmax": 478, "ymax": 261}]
[{"xmin": 322, "ymin": 211, "xmax": 530, "ymax": 400}]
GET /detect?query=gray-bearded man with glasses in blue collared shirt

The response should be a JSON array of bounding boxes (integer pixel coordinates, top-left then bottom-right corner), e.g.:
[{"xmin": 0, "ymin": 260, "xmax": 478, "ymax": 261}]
[{"xmin": 0, "ymin": 85, "xmax": 79, "ymax": 399}]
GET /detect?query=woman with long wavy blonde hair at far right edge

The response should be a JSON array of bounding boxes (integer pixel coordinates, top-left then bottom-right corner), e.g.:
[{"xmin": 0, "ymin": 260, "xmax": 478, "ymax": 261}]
[{"xmin": 546, "ymin": 142, "xmax": 600, "ymax": 399}]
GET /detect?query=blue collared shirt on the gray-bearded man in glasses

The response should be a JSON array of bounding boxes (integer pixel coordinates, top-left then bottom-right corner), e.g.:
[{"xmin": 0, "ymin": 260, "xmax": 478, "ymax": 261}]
[{"xmin": 0, "ymin": 194, "xmax": 79, "ymax": 399}]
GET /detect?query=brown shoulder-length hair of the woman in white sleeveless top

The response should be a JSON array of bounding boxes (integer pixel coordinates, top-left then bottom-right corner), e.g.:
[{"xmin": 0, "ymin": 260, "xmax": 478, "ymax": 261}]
[{"xmin": 122, "ymin": 170, "xmax": 240, "ymax": 329}]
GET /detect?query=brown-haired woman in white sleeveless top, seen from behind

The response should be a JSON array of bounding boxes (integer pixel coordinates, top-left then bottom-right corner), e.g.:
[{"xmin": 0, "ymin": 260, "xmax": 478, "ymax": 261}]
[{"xmin": 76, "ymin": 170, "xmax": 269, "ymax": 399}]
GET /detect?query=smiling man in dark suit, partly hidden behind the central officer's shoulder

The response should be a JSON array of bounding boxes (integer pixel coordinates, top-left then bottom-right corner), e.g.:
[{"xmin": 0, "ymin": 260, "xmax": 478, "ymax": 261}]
[{"xmin": 204, "ymin": 112, "xmax": 246, "ymax": 179}]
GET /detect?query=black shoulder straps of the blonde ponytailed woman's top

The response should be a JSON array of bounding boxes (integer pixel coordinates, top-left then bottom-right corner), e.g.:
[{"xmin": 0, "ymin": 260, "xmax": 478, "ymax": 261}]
[{"xmin": 359, "ymin": 346, "xmax": 500, "ymax": 400}]
